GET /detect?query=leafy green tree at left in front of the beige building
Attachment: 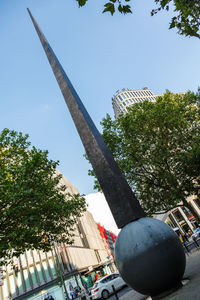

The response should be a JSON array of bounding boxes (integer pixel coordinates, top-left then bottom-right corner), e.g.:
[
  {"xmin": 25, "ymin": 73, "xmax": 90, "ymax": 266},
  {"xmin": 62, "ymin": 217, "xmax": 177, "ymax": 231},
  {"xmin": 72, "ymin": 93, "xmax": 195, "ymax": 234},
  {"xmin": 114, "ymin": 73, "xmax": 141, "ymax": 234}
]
[{"xmin": 0, "ymin": 129, "xmax": 85, "ymax": 264}]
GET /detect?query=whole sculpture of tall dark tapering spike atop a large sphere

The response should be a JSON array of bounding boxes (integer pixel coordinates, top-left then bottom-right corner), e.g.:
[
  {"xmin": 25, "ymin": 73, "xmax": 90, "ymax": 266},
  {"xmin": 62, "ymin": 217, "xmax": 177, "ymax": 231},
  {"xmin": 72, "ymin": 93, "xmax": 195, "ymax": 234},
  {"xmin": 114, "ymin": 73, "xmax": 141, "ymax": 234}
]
[{"xmin": 28, "ymin": 9, "xmax": 185, "ymax": 297}]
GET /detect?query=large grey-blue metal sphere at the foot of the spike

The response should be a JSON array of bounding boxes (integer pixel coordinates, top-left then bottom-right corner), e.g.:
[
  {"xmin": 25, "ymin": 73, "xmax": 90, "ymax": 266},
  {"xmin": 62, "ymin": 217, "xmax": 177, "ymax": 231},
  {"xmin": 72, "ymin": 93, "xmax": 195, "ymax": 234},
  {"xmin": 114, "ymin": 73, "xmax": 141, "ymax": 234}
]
[{"xmin": 115, "ymin": 218, "xmax": 186, "ymax": 297}]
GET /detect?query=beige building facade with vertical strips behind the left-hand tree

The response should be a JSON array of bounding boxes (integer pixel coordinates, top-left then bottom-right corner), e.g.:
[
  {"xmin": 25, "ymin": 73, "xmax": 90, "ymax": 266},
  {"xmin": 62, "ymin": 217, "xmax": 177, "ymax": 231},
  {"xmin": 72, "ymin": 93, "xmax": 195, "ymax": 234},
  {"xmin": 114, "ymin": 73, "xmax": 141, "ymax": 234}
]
[{"xmin": 0, "ymin": 172, "xmax": 112, "ymax": 300}]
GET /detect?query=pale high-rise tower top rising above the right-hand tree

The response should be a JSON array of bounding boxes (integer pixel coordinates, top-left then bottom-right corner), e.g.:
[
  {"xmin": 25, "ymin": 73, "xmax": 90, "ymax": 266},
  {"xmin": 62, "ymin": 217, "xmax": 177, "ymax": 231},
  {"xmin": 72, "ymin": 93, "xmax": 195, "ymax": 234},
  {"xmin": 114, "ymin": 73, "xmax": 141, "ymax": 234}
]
[{"xmin": 112, "ymin": 87, "xmax": 160, "ymax": 119}]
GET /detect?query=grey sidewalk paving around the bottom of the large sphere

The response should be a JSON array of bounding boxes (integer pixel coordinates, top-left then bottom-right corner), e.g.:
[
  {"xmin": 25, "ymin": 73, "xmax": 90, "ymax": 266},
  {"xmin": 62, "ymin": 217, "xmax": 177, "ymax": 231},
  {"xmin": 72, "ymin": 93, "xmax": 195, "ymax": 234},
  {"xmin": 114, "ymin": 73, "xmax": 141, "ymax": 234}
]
[{"xmin": 120, "ymin": 250, "xmax": 200, "ymax": 300}]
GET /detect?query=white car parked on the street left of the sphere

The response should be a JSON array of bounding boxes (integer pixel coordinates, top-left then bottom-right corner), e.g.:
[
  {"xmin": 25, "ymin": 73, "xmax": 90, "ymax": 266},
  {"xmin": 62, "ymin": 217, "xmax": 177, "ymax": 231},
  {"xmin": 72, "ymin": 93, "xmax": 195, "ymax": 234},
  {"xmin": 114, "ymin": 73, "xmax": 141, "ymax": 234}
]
[{"xmin": 91, "ymin": 273, "xmax": 127, "ymax": 299}]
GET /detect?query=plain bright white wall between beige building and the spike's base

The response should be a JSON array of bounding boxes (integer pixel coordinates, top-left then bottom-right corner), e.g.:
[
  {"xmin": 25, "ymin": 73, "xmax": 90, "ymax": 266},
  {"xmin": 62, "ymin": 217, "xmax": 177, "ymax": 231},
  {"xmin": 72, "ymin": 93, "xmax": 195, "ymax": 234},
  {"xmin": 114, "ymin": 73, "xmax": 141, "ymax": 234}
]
[{"xmin": 85, "ymin": 193, "xmax": 120, "ymax": 234}]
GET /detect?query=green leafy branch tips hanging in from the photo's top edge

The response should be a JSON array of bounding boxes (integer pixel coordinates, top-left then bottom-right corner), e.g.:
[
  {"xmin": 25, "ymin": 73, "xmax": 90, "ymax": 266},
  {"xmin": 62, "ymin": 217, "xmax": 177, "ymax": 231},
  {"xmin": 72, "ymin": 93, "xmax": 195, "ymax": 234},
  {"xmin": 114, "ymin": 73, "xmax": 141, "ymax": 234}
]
[{"xmin": 77, "ymin": 0, "xmax": 200, "ymax": 38}]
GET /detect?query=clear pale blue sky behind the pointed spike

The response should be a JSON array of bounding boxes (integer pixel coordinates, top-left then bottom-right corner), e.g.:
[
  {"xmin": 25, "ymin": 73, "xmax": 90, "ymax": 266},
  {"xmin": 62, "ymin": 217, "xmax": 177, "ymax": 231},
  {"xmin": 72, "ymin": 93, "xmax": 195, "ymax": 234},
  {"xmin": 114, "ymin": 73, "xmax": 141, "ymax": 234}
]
[{"xmin": 0, "ymin": 0, "xmax": 200, "ymax": 194}]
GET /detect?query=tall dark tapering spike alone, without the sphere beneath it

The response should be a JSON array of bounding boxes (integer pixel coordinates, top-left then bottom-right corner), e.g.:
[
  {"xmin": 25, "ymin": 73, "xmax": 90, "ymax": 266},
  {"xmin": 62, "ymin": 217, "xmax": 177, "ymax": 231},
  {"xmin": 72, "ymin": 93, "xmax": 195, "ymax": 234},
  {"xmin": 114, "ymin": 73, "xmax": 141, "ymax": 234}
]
[{"xmin": 28, "ymin": 10, "xmax": 145, "ymax": 228}]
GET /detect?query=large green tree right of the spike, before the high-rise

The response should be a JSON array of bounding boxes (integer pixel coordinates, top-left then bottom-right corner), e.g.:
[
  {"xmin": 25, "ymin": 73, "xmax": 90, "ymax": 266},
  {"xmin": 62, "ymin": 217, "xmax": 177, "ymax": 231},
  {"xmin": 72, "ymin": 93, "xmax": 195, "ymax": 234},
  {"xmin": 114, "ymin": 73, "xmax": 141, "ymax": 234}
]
[{"xmin": 89, "ymin": 90, "xmax": 200, "ymax": 220}]
